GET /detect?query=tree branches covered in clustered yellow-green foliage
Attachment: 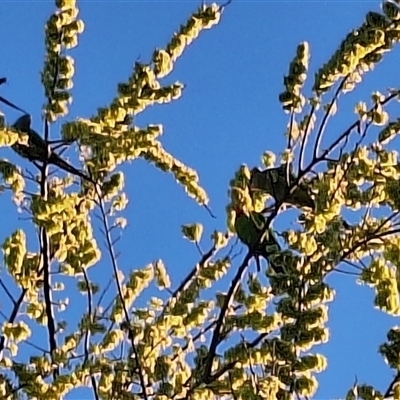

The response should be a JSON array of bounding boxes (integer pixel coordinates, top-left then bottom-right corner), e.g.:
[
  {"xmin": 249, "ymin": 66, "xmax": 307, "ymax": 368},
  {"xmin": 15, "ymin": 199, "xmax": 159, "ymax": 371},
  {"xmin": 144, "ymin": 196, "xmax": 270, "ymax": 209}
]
[{"xmin": 0, "ymin": 0, "xmax": 400, "ymax": 400}]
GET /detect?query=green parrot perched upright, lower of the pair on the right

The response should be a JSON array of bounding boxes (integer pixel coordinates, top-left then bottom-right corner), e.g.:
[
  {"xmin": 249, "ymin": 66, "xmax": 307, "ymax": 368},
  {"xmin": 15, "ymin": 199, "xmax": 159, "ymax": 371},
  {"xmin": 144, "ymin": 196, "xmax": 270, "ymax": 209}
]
[{"xmin": 235, "ymin": 210, "xmax": 285, "ymax": 274}]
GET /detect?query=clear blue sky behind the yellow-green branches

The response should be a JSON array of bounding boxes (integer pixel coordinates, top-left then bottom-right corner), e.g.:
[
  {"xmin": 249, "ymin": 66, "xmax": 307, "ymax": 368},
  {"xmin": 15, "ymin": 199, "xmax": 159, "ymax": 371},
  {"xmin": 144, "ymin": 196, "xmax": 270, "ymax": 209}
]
[{"xmin": 0, "ymin": 0, "xmax": 399, "ymax": 399}]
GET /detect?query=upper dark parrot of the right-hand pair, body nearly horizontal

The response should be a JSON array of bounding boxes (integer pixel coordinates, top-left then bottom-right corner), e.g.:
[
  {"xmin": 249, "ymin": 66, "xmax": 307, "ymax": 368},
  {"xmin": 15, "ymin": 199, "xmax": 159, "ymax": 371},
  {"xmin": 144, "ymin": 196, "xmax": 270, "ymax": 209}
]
[{"xmin": 250, "ymin": 164, "xmax": 315, "ymax": 210}]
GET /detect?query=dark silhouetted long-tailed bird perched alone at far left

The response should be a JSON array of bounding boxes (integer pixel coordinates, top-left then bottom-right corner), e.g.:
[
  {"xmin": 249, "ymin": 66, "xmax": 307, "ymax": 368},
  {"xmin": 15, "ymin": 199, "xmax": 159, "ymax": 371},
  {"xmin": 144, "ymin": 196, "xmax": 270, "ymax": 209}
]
[{"xmin": 11, "ymin": 114, "xmax": 96, "ymax": 184}]
